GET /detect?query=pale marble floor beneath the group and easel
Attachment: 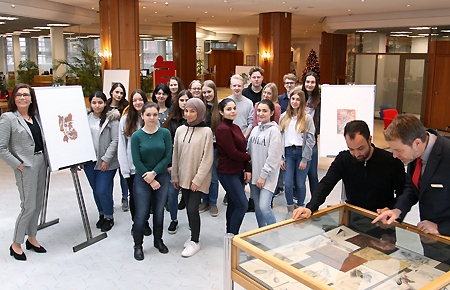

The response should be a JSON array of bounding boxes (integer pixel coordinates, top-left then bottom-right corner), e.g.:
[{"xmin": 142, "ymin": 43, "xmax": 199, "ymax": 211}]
[{"xmin": 0, "ymin": 118, "xmax": 418, "ymax": 289}]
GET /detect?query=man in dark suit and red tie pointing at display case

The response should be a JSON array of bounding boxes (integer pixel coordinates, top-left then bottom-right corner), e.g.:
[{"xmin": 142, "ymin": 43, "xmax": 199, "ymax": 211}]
[{"xmin": 372, "ymin": 115, "xmax": 450, "ymax": 236}]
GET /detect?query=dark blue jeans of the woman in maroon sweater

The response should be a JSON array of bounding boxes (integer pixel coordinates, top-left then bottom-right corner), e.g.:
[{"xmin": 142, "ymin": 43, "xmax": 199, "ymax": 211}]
[{"xmin": 218, "ymin": 172, "xmax": 248, "ymax": 235}]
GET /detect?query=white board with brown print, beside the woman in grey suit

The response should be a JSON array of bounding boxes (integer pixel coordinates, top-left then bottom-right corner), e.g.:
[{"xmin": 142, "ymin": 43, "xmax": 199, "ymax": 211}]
[{"xmin": 34, "ymin": 86, "xmax": 96, "ymax": 171}]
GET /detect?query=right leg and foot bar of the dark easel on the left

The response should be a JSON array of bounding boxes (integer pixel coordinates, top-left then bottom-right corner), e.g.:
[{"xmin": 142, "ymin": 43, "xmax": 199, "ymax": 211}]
[{"xmin": 70, "ymin": 165, "xmax": 108, "ymax": 252}]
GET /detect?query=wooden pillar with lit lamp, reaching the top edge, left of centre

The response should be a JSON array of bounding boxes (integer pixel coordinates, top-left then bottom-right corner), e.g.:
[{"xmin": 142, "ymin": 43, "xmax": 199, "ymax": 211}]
[{"xmin": 100, "ymin": 0, "xmax": 141, "ymax": 91}]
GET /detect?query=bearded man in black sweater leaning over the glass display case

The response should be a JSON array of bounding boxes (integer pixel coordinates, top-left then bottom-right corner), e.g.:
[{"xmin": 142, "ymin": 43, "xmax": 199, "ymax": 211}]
[{"xmin": 293, "ymin": 120, "xmax": 406, "ymax": 218}]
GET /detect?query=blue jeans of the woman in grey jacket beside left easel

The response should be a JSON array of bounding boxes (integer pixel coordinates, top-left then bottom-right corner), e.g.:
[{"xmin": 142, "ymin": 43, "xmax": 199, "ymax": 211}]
[{"xmin": 84, "ymin": 161, "xmax": 117, "ymax": 219}]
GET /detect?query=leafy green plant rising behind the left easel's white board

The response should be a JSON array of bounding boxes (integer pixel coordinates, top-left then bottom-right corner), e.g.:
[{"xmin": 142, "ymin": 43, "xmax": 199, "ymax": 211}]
[{"xmin": 53, "ymin": 42, "xmax": 103, "ymax": 97}]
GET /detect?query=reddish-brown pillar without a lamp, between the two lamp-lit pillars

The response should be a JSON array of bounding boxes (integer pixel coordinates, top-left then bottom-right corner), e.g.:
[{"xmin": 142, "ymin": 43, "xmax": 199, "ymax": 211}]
[{"xmin": 172, "ymin": 22, "xmax": 197, "ymax": 87}]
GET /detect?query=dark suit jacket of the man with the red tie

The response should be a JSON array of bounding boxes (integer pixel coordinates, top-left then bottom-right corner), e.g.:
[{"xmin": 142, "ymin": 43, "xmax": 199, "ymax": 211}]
[{"xmin": 395, "ymin": 130, "xmax": 450, "ymax": 236}]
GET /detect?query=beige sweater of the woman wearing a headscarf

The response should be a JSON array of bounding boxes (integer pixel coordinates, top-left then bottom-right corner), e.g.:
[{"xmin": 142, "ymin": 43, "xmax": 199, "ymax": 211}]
[{"xmin": 172, "ymin": 125, "xmax": 214, "ymax": 193}]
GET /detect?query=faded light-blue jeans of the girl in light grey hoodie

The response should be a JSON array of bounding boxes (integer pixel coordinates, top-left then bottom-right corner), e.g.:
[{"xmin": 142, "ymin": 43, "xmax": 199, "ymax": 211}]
[{"xmin": 250, "ymin": 183, "xmax": 277, "ymax": 228}]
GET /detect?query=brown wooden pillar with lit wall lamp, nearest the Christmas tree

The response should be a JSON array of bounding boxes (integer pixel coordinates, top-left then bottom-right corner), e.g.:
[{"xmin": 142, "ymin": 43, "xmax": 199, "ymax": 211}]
[{"xmin": 258, "ymin": 12, "xmax": 292, "ymax": 92}]
